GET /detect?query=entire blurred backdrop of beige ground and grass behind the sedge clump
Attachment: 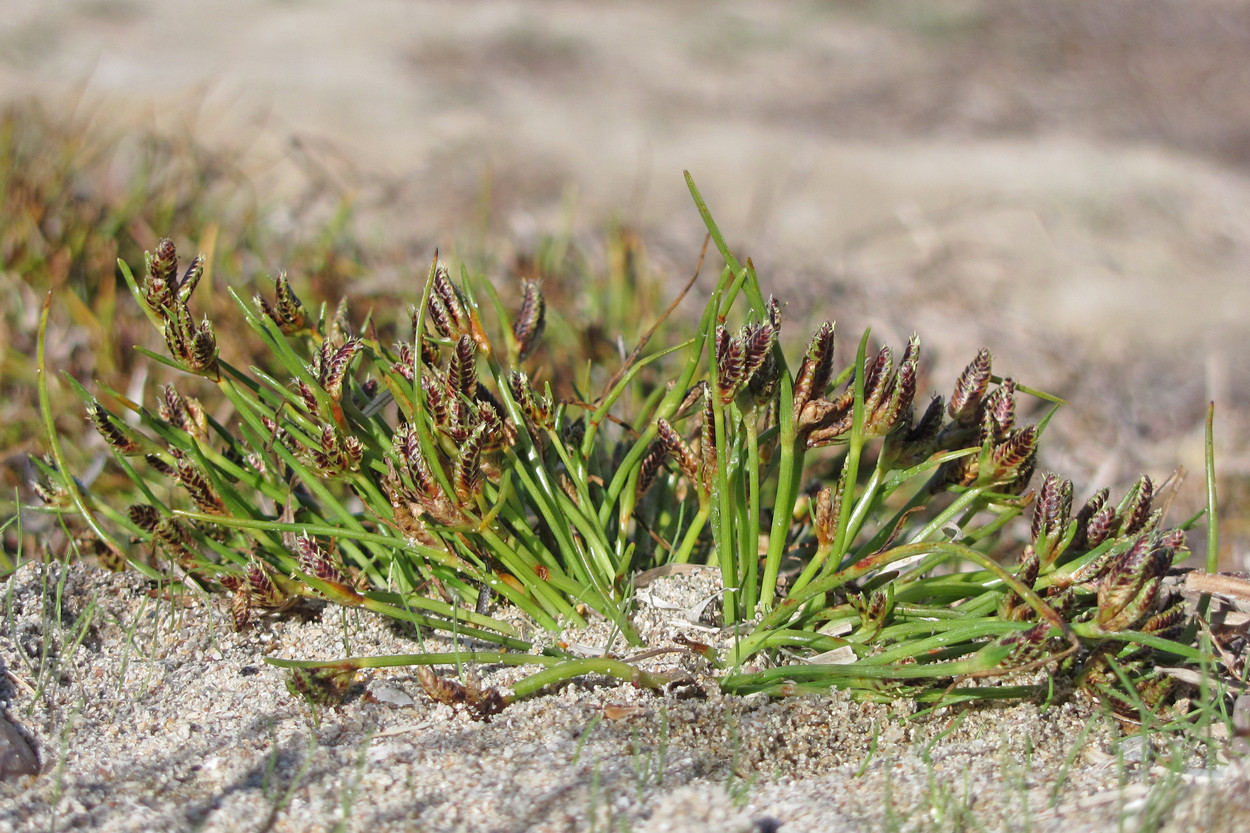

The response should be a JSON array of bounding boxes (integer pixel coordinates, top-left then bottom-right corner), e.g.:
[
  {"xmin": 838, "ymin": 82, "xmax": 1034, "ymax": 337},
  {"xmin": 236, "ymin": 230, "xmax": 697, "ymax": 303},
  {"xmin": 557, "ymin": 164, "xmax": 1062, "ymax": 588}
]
[{"xmin": 0, "ymin": 0, "xmax": 1250, "ymax": 569}]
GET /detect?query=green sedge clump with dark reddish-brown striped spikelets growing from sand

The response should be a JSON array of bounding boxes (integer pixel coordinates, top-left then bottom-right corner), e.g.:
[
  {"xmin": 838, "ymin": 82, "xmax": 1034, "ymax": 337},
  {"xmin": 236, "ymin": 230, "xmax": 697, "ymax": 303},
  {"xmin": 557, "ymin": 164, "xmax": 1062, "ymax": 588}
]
[{"xmin": 40, "ymin": 170, "xmax": 1225, "ymax": 718}]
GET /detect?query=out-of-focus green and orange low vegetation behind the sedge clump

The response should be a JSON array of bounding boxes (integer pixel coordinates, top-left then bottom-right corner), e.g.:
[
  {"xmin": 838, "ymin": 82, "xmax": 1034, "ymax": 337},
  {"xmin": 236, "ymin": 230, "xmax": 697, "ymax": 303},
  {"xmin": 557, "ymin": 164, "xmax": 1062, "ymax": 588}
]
[{"xmin": 0, "ymin": 101, "xmax": 680, "ymax": 565}]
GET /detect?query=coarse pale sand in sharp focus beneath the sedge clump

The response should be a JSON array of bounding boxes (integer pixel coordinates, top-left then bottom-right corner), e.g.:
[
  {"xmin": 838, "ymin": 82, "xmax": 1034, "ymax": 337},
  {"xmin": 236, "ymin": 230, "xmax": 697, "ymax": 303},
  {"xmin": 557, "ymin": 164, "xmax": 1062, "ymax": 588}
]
[{"xmin": 0, "ymin": 557, "xmax": 1250, "ymax": 833}]
